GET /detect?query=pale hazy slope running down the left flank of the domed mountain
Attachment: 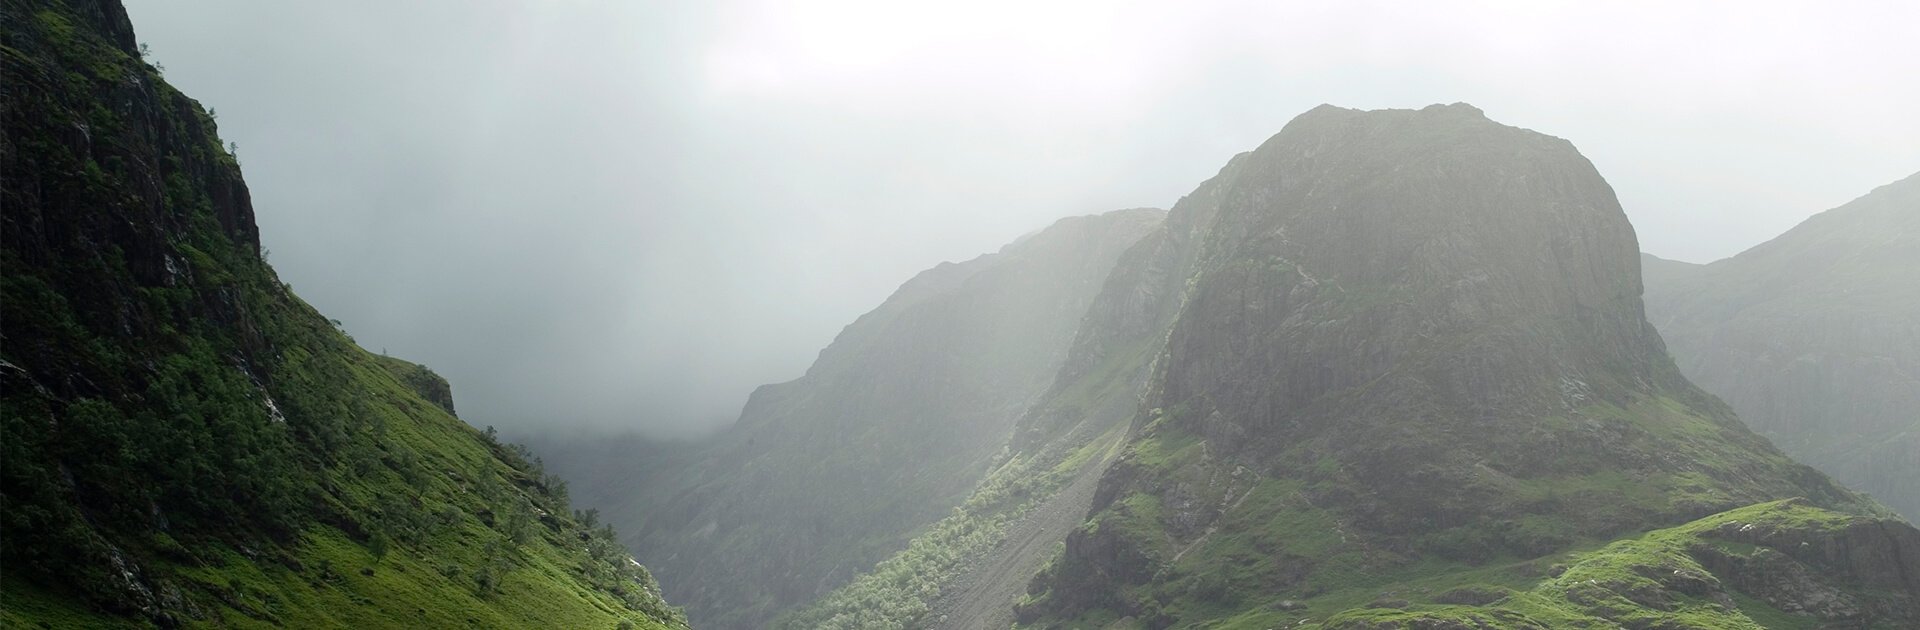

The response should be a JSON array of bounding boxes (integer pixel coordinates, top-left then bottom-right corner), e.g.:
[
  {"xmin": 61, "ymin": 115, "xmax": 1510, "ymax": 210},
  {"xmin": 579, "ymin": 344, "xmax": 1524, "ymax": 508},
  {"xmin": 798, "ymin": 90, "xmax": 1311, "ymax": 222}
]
[{"xmin": 780, "ymin": 140, "xmax": 1240, "ymax": 630}]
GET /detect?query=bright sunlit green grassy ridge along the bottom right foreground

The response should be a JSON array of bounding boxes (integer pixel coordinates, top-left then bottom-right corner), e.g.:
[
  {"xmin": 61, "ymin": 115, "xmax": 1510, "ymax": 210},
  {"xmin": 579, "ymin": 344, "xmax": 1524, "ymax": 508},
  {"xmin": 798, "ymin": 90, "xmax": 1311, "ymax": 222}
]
[{"xmin": 1013, "ymin": 499, "xmax": 1920, "ymax": 630}]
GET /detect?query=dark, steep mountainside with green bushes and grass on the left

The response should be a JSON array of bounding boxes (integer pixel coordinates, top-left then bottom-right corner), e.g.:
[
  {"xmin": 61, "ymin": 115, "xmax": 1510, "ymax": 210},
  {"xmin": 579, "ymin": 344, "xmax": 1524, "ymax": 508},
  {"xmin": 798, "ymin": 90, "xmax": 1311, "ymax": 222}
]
[{"xmin": 0, "ymin": 0, "xmax": 684, "ymax": 628}]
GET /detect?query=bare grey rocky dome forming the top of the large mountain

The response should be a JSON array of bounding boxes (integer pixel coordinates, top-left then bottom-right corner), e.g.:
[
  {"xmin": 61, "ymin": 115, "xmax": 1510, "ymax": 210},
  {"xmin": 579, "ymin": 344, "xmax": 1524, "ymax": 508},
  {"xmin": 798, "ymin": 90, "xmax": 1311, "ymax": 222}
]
[{"xmin": 1164, "ymin": 106, "xmax": 1674, "ymax": 453}]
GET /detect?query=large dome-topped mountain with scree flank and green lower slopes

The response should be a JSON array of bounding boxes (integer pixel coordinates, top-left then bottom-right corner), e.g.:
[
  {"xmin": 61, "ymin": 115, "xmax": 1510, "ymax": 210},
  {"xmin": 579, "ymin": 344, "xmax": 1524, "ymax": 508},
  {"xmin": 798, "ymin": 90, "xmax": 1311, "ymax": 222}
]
[{"xmin": 785, "ymin": 104, "xmax": 1920, "ymax": 628}]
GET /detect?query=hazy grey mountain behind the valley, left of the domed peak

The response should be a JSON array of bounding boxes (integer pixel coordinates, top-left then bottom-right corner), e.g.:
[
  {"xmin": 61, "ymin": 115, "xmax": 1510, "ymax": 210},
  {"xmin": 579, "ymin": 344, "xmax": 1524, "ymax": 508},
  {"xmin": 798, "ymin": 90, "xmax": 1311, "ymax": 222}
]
[{"xmin": 538, "ymin": 209, "xmax": 1164, "ymax": 628}]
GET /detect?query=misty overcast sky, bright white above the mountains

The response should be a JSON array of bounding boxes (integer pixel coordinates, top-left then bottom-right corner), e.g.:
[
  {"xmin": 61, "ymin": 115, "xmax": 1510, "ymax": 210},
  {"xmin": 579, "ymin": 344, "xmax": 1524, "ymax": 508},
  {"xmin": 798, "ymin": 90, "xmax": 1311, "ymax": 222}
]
[{"xmin": 129, "ymin": 0, "xmax": 1920, "ymax": 434}]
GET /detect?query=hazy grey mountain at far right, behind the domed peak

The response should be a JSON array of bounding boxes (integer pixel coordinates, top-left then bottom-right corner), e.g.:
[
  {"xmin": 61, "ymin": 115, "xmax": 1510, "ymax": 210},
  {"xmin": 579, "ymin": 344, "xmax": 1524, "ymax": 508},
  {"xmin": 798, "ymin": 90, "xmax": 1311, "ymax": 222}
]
[{"xmin": 1644, "ymin": 175, "xmax": 1920, "ymax": 519}]
